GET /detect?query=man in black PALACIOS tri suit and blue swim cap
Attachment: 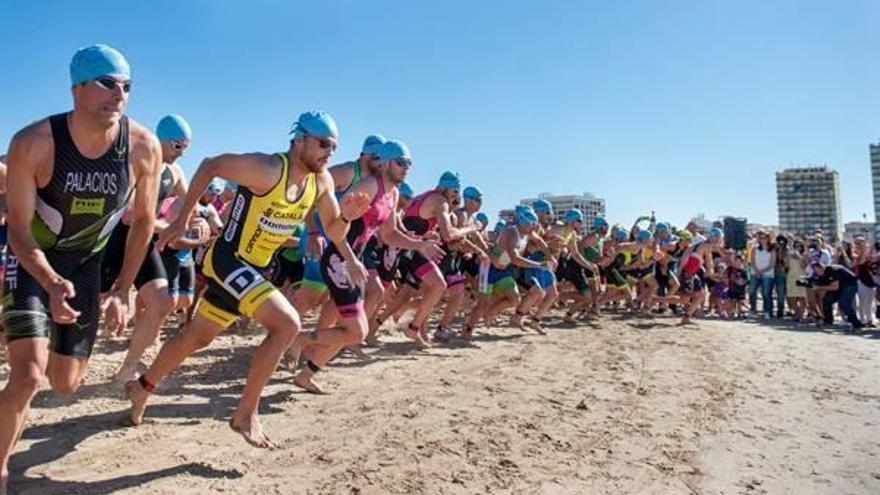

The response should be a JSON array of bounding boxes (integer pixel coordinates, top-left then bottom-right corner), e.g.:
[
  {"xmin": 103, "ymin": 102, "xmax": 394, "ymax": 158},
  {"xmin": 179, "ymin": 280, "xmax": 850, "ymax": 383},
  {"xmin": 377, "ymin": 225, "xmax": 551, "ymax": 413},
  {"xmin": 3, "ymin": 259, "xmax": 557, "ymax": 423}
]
[{"xmin": 0, "ymin": 45, "xmax": 162, "ymax": 493}]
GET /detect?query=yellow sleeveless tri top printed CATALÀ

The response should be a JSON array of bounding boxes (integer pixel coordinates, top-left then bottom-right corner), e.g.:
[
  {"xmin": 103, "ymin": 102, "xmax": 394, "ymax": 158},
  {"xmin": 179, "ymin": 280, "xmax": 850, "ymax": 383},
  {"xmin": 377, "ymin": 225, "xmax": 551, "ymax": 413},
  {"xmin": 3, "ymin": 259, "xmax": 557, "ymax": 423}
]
[{"xmin": 214, "ymin": 153, "xmax": 318, "ymax": 268}]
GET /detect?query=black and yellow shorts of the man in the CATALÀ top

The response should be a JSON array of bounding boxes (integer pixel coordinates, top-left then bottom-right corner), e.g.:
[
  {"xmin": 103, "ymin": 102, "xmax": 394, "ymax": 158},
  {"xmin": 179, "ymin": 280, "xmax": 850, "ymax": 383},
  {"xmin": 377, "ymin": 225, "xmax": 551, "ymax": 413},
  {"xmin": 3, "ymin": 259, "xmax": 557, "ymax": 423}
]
[{"xmin": 198, "ymin": 242, "xmax": 278, "ymax": 327}]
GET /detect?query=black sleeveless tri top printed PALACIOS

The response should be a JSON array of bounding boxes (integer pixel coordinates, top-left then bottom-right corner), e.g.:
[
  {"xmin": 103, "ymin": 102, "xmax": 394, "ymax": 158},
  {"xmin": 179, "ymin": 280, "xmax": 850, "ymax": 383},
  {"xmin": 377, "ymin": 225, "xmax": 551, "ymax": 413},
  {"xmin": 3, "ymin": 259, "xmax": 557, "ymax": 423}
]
[{"xmin": 31, "ymin": 114, "xmax": 131, "ymax": 254}]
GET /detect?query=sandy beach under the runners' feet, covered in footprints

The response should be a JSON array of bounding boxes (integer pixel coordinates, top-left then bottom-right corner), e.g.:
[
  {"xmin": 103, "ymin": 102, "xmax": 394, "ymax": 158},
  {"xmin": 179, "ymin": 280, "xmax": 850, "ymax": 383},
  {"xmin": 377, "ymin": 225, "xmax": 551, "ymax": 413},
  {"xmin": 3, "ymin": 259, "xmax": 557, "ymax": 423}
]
[{"xmin": 0, "ymin": 315, "xmax": 880, "ymax": 495}]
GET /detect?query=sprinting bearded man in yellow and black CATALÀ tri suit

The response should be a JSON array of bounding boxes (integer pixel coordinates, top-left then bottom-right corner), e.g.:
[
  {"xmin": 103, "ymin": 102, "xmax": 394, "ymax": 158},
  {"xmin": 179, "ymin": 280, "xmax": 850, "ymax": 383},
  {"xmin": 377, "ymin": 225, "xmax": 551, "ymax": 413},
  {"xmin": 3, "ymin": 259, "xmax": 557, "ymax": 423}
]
[{"xmin": 126, "ymin": 112, "xmax": 369, "ymax": 448}]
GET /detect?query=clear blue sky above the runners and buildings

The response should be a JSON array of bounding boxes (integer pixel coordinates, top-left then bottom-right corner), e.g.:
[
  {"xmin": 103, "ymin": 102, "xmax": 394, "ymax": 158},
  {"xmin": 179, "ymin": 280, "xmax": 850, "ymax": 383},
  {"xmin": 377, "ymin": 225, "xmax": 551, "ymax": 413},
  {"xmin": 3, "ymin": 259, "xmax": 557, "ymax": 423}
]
[{"xmin": 0, "ymin": 0, "xmax": 880, "ymax": 227}]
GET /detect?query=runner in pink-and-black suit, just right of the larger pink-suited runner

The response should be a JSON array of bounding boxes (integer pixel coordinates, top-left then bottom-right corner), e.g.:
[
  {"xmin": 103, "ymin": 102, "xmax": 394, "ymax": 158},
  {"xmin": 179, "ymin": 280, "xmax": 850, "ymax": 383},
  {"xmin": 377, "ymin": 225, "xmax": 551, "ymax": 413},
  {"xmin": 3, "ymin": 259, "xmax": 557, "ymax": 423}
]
[{"xmin": 399, "ymin": 172, "xmax": 477, "ymax": 349}]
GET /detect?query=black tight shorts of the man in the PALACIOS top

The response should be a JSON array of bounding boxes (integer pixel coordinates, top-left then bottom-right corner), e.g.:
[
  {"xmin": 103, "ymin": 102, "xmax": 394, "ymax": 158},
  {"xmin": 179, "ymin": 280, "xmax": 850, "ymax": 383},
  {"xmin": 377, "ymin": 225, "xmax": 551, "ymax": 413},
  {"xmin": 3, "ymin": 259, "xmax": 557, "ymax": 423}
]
[{"xmin": 3, "ymin": 251, "xmax": 101, "ymax": 358}]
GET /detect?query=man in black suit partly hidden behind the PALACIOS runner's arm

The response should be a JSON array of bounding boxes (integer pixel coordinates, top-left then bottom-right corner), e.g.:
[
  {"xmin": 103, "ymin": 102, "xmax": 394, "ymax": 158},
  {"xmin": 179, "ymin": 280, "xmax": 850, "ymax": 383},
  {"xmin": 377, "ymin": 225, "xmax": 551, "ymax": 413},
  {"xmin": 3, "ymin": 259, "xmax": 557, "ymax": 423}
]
[{"xmin": 101, "ymin": 114, "xmax": 192, "ymax": 384}]
